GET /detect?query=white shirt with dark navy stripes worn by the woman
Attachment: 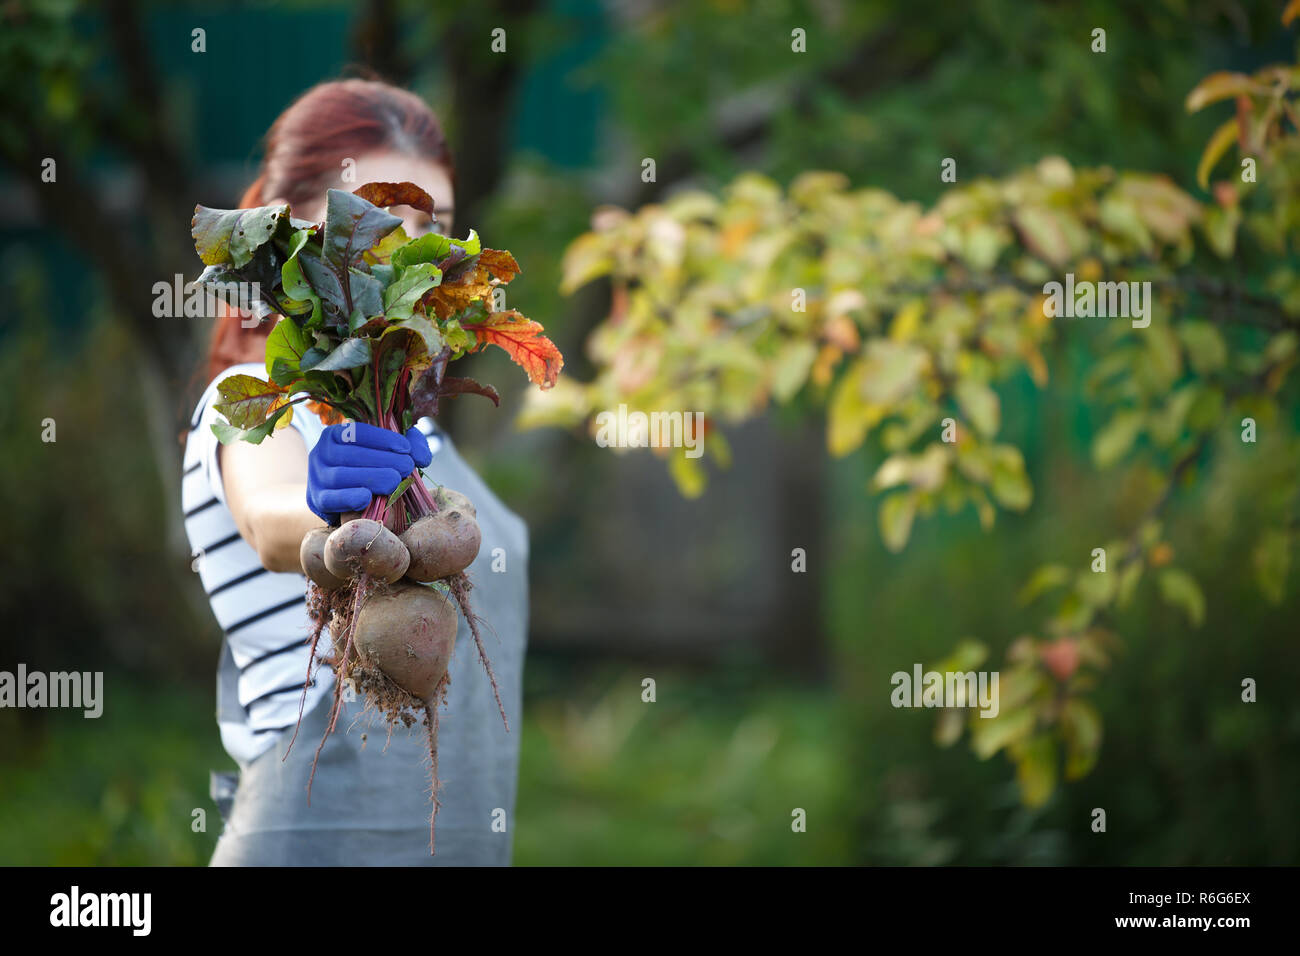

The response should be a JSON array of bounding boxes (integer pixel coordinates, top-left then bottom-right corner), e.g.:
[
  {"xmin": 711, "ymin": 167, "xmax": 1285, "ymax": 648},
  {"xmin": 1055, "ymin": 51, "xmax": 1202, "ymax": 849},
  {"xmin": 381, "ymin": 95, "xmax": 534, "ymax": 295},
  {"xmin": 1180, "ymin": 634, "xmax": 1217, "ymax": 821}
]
[{"xmin": 181, "ymin": 363, "xmax": 441, "ymax": 765}]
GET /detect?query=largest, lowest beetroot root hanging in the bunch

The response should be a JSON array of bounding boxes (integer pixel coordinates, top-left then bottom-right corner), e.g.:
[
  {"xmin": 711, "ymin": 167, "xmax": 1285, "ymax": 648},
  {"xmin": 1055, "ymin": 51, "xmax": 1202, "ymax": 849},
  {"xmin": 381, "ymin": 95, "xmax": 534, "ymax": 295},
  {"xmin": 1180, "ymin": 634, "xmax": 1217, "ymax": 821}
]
[{"xmin": 355, "ymin": 584, "xmax": 459, "ymax": 701}]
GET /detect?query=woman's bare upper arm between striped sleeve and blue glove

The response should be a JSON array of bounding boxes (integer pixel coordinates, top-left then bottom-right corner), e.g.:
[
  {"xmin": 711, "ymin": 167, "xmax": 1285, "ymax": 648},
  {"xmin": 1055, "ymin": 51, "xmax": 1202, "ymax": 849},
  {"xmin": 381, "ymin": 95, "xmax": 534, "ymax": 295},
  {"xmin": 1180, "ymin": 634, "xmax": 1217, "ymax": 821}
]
[{"xmin": 217, "ymin": 428, "xmax": 325, "ymax": 574}]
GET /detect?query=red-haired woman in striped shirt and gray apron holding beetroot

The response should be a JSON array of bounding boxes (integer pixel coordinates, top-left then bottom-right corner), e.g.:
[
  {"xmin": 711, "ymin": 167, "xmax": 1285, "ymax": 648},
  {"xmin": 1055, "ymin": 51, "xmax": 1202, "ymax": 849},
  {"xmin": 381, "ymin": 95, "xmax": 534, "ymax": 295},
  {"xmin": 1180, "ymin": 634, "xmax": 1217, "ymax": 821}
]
[{"xmin": 182, "ymin": 79, "xmax": 528, "ymax": 866}]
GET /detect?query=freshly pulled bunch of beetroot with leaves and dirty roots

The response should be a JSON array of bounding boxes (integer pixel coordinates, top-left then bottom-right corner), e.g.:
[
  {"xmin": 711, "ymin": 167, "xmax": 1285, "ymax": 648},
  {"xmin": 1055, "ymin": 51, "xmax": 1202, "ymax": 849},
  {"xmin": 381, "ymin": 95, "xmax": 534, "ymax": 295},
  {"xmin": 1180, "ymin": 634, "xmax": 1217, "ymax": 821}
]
[{"xmin": 192, "ymin": 182, "xmax": 563, "ymax": 852}]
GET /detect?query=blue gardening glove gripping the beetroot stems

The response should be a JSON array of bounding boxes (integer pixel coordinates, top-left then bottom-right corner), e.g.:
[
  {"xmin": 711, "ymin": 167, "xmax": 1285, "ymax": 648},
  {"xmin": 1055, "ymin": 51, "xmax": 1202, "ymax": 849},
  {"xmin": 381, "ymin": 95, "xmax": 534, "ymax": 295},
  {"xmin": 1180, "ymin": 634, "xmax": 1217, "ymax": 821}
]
[{"xmin": 307, "ymin": 421, "xmax": 433, "ymax": 524}]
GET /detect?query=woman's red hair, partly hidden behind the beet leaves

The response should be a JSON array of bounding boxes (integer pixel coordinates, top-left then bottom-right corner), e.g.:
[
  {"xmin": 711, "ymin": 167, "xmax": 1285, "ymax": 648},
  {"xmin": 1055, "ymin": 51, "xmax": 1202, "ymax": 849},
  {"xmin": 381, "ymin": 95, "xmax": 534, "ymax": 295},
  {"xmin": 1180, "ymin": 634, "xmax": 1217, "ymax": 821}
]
[{"xmin": 204, "ymin": 79, "xmax": 455, "ymax": 382}]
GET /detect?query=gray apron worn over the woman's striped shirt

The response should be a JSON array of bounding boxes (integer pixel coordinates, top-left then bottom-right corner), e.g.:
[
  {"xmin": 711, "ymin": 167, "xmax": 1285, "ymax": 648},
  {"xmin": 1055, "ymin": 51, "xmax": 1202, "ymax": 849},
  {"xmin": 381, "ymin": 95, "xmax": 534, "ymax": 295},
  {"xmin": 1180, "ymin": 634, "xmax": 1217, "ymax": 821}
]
[{"xmin": 212, "ymin": 433, "xmax": 528, "ymax": 866}]
